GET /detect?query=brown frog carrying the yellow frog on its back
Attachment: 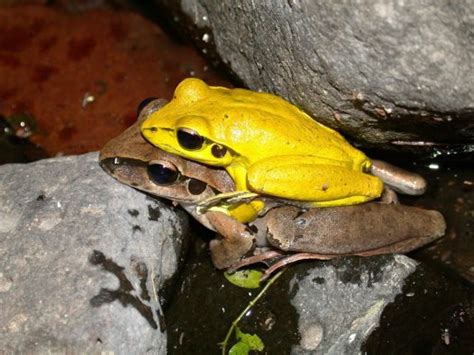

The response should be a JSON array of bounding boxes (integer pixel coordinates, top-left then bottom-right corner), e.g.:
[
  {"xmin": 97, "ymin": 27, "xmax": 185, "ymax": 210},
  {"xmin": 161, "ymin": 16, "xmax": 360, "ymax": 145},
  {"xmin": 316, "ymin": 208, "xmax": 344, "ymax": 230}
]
[{"xmin": 100, "ymin": 100, "xmax": 445, "ymax": 269}]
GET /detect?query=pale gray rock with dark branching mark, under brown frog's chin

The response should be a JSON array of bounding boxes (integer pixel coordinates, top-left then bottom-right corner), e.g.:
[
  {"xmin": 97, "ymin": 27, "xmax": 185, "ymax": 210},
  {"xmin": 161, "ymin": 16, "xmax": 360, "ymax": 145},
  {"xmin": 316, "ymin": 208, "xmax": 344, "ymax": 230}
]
[{"xmin": 0, "ymin": 153, "xmax": 187, "ymax": 354}]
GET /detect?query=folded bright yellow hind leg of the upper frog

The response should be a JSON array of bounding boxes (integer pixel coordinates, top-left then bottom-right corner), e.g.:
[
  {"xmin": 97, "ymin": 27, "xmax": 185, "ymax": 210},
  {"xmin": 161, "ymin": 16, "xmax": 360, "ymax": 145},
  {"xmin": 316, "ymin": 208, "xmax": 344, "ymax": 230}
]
[{"xmin": 247, "ymin": 155, "xmax": 383, "ymax": 206}]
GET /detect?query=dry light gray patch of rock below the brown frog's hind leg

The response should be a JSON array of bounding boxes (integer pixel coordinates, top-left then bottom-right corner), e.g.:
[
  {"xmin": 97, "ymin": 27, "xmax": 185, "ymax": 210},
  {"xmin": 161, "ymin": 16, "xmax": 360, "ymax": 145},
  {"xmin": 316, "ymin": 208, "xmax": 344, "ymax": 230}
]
[{"xmin": 291, "ymin": 255, "xmax": 417, "ymax": 354}]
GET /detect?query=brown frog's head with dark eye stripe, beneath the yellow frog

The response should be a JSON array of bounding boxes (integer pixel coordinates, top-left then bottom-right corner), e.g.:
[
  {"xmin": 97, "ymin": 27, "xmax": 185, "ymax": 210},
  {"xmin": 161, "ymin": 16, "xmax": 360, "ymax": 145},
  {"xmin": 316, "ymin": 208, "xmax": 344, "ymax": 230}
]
[{"xmin": 99, "ymin": 100, "xmax": 234, "ymax": 204}]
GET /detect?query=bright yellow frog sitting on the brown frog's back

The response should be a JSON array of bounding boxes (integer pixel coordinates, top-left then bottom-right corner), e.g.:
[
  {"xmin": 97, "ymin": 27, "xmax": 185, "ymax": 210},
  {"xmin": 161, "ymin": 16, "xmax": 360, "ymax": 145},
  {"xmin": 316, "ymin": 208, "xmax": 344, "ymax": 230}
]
[{"xmin": 142, "ymin": 78, "xmax": 383, "ymax": 221}]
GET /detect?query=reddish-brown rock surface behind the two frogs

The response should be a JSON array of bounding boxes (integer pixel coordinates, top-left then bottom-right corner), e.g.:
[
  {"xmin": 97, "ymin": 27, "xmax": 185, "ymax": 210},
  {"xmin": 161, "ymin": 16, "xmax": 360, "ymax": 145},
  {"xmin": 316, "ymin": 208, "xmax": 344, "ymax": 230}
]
[{"xmin": 0, "ymin": 6, "xmax": 229, "ymax": 155}]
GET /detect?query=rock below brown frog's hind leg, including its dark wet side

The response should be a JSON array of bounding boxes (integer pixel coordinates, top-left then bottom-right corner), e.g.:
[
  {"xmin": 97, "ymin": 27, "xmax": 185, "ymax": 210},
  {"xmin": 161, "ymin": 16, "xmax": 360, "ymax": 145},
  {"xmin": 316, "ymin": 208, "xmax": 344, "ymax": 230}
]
[{"xmin": 291, "ymin": 255, "xmax": 474, "ymax": 354}]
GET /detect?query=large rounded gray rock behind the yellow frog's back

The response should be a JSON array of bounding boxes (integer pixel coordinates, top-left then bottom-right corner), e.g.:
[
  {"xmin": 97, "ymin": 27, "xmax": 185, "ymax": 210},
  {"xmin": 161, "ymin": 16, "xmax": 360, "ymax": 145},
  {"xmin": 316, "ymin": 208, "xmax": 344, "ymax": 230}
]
[{"xmin": 160, "ymin": 0, "xmax": 474, "ymax": 152}]
